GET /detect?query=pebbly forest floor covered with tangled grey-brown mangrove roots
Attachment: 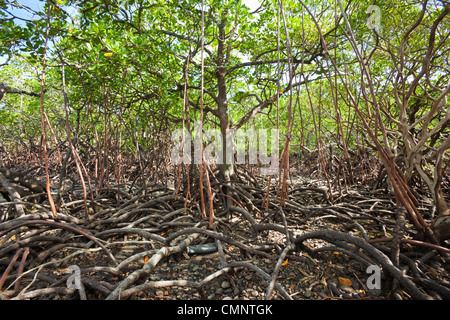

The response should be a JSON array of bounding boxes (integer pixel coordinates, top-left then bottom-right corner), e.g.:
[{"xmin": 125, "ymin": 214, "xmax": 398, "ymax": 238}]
[{"xmin": 0, "ymin": 168, "xmax": 450, "ymax": 300}]
